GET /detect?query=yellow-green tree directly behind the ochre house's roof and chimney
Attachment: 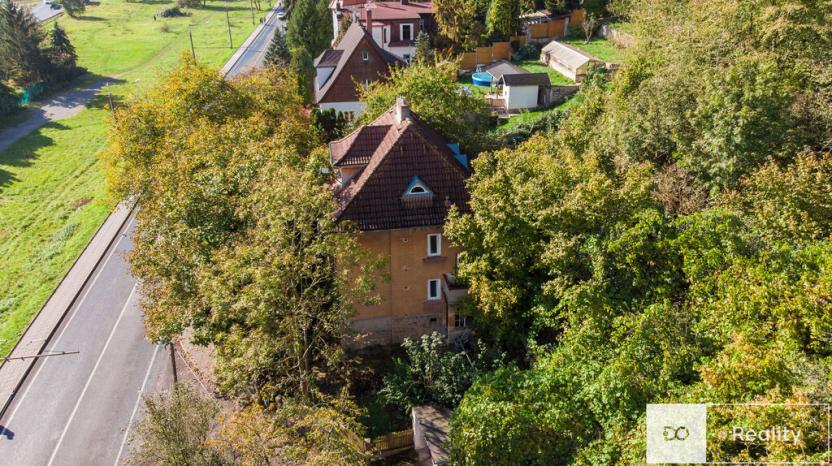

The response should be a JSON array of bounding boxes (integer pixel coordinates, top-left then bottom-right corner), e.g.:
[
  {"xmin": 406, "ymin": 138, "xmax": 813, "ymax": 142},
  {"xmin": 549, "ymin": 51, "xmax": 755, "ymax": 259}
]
[{"xmin": 361, "ymin": 63, "xmax": 494, "ymax": 152}]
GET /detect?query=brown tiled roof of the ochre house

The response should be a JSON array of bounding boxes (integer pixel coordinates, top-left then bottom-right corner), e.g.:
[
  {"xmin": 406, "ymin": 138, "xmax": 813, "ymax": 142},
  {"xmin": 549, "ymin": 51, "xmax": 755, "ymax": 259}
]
[{"xmin": 330, "ymin": 106, "xmax": 469, "ymax": 231}]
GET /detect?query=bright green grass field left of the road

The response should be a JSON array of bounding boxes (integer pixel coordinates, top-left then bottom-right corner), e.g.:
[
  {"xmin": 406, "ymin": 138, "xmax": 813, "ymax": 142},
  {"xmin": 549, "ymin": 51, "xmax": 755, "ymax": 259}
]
[{"xmin": 0, "ymin": 0, "xmax": 265, "ymax": 355}]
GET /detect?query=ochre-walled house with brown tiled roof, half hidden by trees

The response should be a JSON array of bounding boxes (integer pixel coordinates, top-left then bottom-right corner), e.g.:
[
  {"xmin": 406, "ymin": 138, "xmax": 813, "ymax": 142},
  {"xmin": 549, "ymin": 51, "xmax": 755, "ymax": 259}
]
[{"xmin": 329, "ymin": 98, "xmax": 470, "ymax": 344}]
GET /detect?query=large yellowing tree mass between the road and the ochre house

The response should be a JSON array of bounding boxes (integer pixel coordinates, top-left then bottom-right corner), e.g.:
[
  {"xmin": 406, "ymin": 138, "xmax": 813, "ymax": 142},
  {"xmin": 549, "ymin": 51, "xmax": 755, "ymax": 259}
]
[{"xmin": 105, "ymin": 57, "xmax": 380, "ymax": 405}]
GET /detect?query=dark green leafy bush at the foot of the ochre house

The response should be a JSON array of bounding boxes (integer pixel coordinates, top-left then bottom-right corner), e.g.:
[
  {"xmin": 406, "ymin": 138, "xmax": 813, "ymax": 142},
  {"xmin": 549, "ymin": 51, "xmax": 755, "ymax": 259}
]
[{"xmin": 379, "ymin": 332, "xmax": 504, "ymax": 413}]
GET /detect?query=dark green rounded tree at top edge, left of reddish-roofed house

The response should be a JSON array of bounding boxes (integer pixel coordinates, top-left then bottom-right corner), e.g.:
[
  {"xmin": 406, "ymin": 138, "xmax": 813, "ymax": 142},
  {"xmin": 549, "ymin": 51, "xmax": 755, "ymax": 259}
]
[{"xmin": 286, "ymin": 0, "xmax": 333, "ymax": 58}]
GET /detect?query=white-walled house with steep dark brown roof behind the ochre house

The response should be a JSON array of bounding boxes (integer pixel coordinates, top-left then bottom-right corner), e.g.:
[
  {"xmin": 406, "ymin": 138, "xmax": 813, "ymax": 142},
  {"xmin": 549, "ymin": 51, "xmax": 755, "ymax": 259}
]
[{"xmin": 314, "ymin": 23, "xmax": 405, "ymax": 120}]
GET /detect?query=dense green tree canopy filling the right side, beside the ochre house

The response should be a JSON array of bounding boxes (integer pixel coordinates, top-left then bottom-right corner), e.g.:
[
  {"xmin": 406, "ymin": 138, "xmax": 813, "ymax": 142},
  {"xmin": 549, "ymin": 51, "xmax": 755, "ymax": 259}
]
[{"xmin": 446, "ymin": 0, "xmax": 832, "ymax": 465}]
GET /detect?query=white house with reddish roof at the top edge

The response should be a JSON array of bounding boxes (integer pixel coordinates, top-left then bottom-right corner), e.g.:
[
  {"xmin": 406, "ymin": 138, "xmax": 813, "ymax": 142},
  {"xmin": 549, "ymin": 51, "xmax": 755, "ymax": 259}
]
[{"xmin": 329, "ymin": 0, "xmax": 437, "ymax": 62}]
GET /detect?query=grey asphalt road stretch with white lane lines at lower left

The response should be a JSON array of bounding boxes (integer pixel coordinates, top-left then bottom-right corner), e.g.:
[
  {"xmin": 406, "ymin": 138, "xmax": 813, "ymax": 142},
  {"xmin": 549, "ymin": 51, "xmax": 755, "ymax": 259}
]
[{"xmin": 0, "ymin": 219, "xmax": 170, "ymax": 465}]
